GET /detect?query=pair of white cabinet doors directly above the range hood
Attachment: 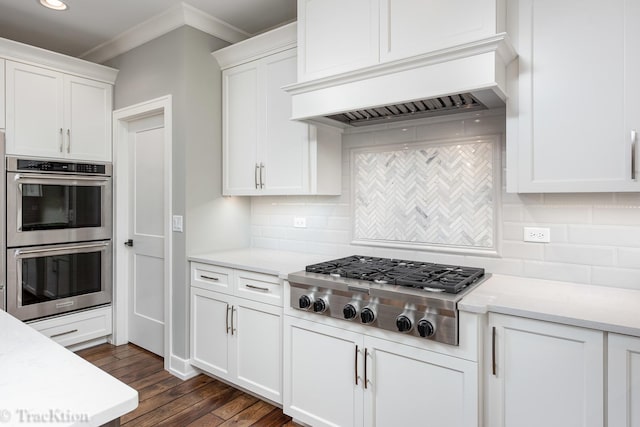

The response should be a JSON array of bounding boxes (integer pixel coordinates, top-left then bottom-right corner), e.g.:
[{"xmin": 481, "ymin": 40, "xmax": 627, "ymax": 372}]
[{"xmin": 298, "ymin": 0, "xmax": 504, "ymax": 82}]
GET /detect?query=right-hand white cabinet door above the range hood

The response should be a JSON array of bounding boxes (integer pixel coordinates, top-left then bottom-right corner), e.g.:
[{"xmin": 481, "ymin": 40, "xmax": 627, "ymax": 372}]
[{"xmin": 380, "ymin": 0, "xmax": 498, "ymax": 62}]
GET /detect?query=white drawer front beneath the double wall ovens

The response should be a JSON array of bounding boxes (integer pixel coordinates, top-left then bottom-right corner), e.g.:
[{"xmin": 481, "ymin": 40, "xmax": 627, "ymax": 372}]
[{"xmin": 29, "ymin": 307, "xmax": 113, "ymax": 347}]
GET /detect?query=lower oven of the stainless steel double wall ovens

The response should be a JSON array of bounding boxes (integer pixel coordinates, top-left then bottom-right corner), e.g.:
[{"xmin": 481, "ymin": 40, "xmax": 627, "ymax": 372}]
[{"xmin": 7, "ymin": 240, "xmax": 112, "ymax": 320}]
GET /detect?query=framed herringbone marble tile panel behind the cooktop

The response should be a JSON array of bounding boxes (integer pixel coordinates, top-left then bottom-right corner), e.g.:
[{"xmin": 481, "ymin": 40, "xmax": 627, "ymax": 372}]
[{"xmin": 352, "ymin": 139, "xmax": 495, "ymax": 248}]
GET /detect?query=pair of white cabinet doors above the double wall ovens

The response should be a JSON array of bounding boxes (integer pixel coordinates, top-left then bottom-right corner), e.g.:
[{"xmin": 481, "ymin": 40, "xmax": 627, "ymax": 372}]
[{"xmin": 6, "ymin": 61, "xmax": 112, "ymax": 161}]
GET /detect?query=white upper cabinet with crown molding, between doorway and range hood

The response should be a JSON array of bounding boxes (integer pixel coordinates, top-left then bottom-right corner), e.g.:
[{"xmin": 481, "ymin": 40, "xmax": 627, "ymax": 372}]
[{"xmin": 213, "ymin": 24, "xmax": 342, "ymax": 196}]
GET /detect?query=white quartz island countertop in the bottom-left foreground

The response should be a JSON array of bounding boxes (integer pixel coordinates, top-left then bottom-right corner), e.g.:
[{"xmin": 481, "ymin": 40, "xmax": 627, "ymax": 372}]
[{"xmin": 0, "ymin": 310, "xmax": 138, "ymax": 427}]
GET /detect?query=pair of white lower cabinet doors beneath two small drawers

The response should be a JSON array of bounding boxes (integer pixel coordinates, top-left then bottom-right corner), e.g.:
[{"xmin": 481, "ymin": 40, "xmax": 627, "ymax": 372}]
[{"xmin": 191, "ymin": 287, "xmax": 282, "ymax": 403}]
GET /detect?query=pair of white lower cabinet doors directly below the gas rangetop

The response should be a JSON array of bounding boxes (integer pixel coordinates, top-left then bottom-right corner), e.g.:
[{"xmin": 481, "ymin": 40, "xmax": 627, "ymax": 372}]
[{"xmin": 284, "ymin": 316, "xmax": 478, "ymax": 427}]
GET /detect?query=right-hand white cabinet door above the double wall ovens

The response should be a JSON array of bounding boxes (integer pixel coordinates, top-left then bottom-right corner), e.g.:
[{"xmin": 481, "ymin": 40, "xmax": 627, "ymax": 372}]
[{"xmin": 64, "ymin": 76, "xmax": 113, "ymax": 161}]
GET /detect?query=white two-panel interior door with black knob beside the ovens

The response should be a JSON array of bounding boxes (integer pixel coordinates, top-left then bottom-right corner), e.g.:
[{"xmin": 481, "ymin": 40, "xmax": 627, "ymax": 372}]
[{"xmin": 128, "ymin": 114, "xmax": 168, "ymax": 357}]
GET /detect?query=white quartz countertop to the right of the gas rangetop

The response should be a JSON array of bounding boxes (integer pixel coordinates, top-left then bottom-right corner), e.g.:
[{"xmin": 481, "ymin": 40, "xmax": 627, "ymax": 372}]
[{"xmin": 458, "ymin": 274, "xmax": 640, "ymax": 336}]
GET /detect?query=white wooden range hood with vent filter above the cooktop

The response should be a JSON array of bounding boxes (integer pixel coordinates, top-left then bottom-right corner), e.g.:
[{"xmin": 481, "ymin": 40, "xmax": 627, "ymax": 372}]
[{"xmin": 284, "ymin": 33, "xmax": 516, "ymax": 128}]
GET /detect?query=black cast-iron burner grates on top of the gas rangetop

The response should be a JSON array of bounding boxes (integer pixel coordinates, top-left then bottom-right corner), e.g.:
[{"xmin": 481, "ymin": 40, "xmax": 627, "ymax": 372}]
[{"xmin": 306, "ymin": 255, "xmax": 484, "ymax": 294}]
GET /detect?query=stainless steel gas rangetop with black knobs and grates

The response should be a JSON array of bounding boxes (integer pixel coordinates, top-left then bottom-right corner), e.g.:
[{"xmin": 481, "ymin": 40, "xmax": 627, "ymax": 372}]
[{"xmin": 288, "ymin": 255, "xmax": 484, "ymax": 345}]
